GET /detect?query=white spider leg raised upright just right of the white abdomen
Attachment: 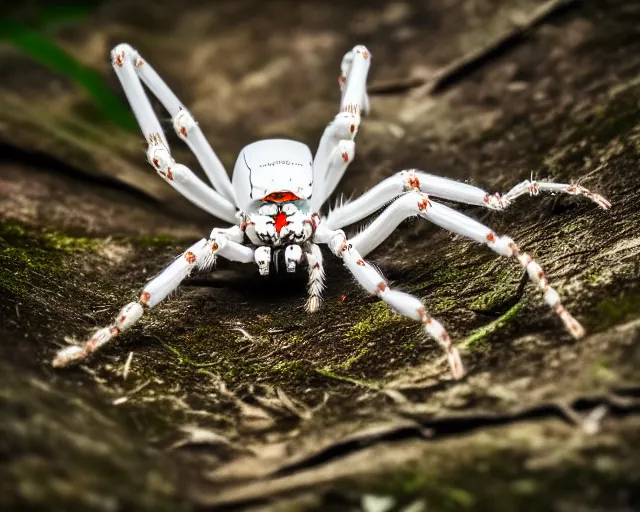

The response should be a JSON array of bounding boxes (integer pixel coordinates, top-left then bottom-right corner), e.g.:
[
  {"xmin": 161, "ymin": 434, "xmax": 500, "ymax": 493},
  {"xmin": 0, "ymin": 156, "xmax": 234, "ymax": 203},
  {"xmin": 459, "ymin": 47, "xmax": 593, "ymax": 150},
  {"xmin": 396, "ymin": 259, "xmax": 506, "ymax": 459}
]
[{"xmin": 311, "ymin": 45, "xmax": 371, "ymax": 211}]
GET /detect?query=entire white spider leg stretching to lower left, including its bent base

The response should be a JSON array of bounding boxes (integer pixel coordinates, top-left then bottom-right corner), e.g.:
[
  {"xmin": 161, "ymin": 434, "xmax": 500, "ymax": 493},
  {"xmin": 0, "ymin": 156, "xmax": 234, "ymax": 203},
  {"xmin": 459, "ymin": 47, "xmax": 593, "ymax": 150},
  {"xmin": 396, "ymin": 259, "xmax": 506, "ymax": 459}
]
[{"xmin": 52, "ymin": 228, "xmax": 253, "ymax": 368}]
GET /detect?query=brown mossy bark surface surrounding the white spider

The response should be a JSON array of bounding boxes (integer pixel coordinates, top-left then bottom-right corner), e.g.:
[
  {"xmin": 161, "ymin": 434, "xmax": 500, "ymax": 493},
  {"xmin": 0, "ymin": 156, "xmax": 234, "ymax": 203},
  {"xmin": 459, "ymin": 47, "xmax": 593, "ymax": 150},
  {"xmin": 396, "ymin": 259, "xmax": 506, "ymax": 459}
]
[{"xmin": 0, "ymin": 0, "xmax": 640, "ymax": 511}]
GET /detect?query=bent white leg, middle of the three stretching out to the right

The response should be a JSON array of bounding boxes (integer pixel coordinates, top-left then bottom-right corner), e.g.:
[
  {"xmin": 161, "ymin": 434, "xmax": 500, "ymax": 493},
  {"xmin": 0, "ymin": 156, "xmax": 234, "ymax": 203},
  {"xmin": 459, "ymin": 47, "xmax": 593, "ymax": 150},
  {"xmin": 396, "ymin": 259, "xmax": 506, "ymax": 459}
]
[{"xmin": 351, "ymin": 191, "xmax": 584, "ymax": 338}]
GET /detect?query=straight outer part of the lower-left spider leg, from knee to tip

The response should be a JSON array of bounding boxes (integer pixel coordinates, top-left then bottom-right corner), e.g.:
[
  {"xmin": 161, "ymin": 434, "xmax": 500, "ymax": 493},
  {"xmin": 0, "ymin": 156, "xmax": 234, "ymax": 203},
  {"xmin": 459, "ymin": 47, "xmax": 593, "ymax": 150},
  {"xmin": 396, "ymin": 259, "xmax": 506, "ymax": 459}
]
[{"xmin": 51, "ymin": 238, "xmax": 209, "ymax": 368}]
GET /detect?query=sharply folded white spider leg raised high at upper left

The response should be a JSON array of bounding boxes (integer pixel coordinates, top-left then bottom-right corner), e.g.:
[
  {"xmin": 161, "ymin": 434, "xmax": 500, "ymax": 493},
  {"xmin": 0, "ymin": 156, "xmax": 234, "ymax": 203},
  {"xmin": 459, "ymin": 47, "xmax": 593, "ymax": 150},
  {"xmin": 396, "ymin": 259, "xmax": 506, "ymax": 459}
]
[{"xmin": 111, "ymin": 44, "xmax": 237, "ymax": 223}]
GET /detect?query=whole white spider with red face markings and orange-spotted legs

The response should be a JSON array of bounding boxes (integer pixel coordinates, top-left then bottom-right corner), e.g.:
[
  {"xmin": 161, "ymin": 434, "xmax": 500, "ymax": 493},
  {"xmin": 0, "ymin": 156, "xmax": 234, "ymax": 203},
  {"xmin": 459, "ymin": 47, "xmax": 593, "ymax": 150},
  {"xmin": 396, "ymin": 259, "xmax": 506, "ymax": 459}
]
[{"xmin": 53, "ymin": 44, "xmax": 610, "ymax": 378}]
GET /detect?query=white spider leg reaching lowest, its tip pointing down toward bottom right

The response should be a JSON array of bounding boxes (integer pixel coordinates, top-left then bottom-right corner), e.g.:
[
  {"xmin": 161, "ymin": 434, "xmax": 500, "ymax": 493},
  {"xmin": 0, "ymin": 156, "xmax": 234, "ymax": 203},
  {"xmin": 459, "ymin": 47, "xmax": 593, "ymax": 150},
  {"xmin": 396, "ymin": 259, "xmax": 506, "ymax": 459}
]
[{"xmin": 316, "ymin": 225, "xmax": 464, "ymax": 379}]
